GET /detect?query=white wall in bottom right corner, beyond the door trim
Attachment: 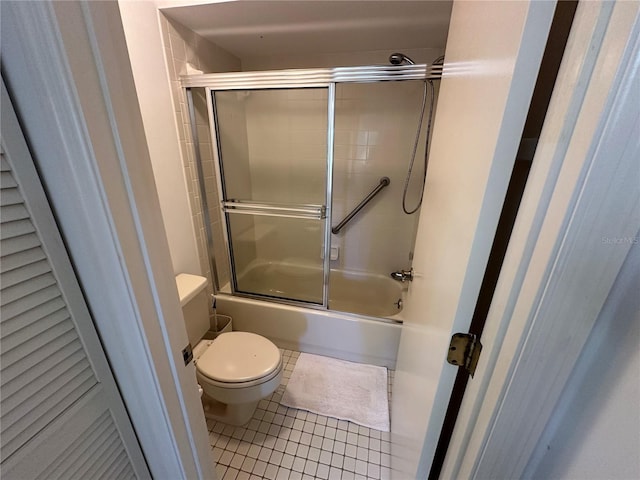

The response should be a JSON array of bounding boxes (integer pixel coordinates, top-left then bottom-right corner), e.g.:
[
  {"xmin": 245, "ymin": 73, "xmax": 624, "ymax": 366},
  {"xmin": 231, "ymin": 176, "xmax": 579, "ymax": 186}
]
[{"xmin": 525, "ymin": 244, "xmax": 640, "ymax": 480}]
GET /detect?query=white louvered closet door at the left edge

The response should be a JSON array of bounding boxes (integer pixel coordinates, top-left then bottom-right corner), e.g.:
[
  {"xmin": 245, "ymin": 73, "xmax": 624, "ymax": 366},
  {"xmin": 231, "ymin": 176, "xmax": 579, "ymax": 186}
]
[{"xmin": 0, "ymin": 84, "xmax": 150, "ymax": 480}]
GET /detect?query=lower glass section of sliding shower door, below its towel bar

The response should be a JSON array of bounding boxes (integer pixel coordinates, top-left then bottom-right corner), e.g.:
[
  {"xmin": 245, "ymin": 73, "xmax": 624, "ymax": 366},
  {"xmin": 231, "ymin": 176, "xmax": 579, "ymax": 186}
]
[{"xmin": 227, "ymin": 212, "xmax": 324, "ymax": 305}]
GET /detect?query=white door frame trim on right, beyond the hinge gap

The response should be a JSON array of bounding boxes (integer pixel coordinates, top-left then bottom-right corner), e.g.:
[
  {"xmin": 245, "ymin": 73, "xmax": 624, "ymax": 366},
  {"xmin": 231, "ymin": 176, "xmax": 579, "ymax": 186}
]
[{"xmin": 441, "ymin": 2, "xmax": 640, "ymax": 478}]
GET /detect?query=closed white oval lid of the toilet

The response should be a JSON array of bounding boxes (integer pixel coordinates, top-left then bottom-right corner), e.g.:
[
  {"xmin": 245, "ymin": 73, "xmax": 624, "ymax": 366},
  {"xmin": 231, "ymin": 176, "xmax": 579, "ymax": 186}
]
[{"xmin": 197, "ymin": 332, "xmax": 280, "ymax": 382}]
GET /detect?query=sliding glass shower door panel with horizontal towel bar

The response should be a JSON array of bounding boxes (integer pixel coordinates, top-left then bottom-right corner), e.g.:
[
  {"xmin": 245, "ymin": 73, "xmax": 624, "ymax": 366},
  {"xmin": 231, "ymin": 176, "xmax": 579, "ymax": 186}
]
[{"xmin": 213, "ymin": 88, "xmax": 328, "ymax": 305}]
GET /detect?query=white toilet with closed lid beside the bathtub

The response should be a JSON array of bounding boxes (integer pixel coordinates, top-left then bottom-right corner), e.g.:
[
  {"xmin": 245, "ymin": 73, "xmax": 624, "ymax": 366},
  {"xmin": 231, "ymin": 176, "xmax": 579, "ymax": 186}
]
[{"xmin": 176, "ymin": 273, "xmax": 282, "ymax": 425}]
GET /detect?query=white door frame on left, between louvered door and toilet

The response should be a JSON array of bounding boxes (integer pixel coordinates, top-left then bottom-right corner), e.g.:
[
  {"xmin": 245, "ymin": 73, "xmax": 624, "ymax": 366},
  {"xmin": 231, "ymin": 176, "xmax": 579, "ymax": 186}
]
[{"xmin": 2, "ymin": 1, "xmax": 215, "ymax": 479}]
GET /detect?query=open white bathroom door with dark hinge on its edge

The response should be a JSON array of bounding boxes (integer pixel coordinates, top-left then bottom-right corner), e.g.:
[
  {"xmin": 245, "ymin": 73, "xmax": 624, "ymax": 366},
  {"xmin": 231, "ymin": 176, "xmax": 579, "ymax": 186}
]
[{"xmin": 391, "ymin": 1, "xmax": 555, "ymax": 479}]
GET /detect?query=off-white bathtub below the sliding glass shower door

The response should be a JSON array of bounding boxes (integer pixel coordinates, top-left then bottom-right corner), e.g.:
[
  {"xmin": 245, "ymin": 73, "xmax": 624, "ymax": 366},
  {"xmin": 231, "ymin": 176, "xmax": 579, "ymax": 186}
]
[{"xmin": 216, "ymin": 270, "xmax": 403, "ymax": 369}]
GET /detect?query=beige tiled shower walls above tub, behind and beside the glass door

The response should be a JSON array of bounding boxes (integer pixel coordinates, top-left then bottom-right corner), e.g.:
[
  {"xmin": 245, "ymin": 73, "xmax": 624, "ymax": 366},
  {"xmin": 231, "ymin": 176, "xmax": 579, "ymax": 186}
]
[{"xmin": 214, "ymin": 81, "xmax": 426, "ymax": 276}]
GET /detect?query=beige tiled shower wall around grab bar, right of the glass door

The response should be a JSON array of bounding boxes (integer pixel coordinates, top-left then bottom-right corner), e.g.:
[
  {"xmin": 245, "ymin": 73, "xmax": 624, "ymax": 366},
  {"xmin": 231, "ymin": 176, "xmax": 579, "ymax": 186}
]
[{"xmin": 332, "ymin": 82, "xmax": 432, "ymax": 275}]
